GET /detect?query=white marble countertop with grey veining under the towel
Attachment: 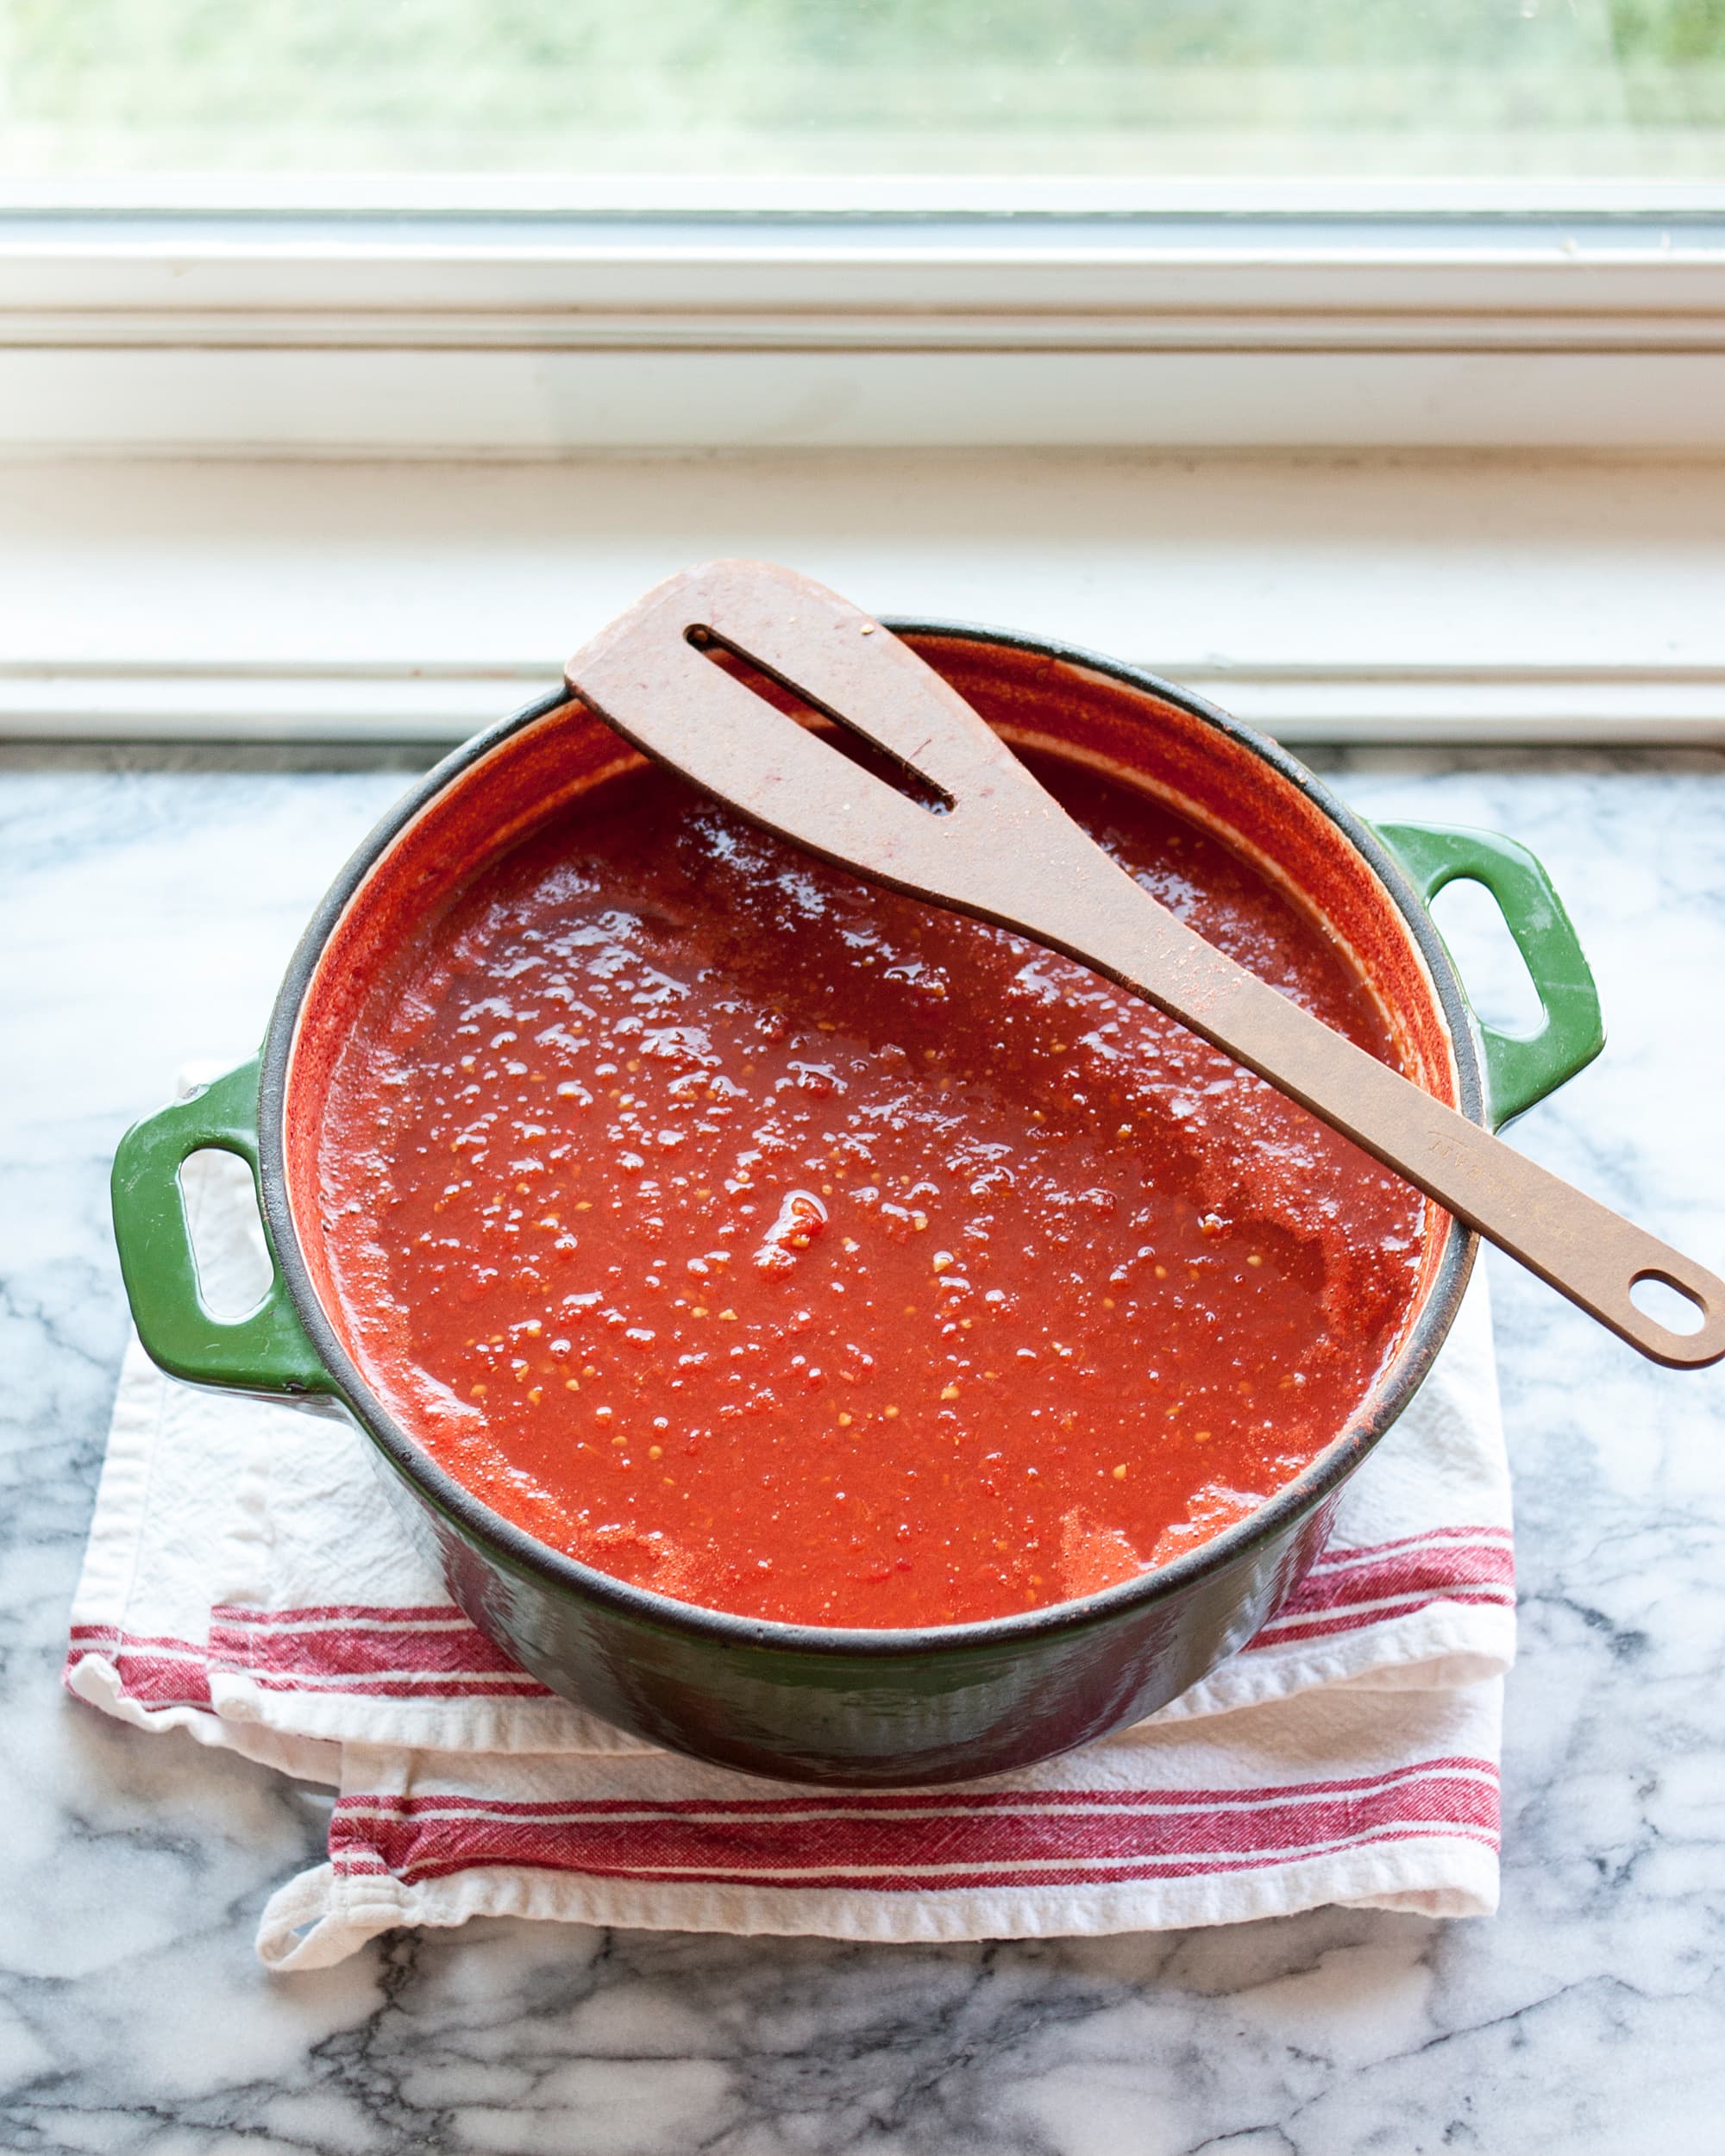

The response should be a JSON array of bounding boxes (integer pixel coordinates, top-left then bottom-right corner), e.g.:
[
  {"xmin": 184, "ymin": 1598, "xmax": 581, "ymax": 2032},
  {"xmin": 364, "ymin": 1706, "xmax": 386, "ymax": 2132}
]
[{"xmin": 0, "ymin": 753, "xmax": 1725, "ymax": 2156}]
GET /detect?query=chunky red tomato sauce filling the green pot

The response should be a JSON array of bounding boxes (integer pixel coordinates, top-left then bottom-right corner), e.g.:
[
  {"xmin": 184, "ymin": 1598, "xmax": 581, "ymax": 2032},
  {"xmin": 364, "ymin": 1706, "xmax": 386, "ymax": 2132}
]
[{"xmin": 319, "ymin": 759, "xmax": 1423, "ymax": 1628}]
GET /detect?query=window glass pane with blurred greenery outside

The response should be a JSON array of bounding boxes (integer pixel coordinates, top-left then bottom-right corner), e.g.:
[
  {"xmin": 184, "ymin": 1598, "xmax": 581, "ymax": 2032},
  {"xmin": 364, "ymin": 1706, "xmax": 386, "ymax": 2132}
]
[{"xmin": 0, "ymin": 0, "xmax": 1725, "ymax": 184}]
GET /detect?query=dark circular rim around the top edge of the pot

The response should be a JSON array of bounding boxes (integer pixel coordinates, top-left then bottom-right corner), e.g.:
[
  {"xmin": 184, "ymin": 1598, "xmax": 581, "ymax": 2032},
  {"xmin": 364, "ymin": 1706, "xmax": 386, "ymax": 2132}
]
[{"xmin": 259, "ymin": 615, "xmax": 1484, "ymax": 1660}]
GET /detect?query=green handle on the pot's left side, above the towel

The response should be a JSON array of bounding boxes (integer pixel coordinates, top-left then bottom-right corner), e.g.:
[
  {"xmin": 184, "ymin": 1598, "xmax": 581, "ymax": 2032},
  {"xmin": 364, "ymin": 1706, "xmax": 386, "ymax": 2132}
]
[{"xmin": 112, "ymin": 1061, "xmax": 335, "ymax": 1395}]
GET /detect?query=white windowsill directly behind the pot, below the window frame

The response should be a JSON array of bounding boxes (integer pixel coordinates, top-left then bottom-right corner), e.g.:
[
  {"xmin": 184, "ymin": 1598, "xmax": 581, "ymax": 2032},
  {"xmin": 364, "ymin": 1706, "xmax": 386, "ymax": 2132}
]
[{"xmin": 0, "ymin": 451, "xmax": 1725, "ymax": 746}]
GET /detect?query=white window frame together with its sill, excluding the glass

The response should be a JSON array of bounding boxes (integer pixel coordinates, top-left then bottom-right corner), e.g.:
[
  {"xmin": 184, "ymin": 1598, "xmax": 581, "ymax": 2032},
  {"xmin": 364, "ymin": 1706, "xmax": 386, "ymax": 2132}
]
[{"xmin": 0, "ymin": 179, "xmax": 1725, "ymax": 746}]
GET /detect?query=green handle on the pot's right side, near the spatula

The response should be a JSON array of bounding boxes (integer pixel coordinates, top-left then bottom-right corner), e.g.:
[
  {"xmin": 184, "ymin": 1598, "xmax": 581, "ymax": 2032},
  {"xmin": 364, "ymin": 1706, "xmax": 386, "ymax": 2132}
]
[{"xmin": 1376, "ymin": 824, "xmax": 1604, "ymax": 1130}]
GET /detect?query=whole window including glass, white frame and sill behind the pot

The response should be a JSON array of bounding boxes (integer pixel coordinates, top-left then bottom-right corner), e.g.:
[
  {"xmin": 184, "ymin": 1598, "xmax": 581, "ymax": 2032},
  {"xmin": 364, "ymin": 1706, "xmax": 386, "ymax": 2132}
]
[{"xmin": 0, "ymin": 0, "xmax": 1725, "ymax": 759}]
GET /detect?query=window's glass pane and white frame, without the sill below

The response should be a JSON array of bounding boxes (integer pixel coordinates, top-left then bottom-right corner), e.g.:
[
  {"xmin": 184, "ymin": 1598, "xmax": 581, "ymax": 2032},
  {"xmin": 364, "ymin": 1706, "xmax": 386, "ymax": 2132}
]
[{"xmin": 0, "ymin": 0, "xmax": 1725, "ymax": 455}]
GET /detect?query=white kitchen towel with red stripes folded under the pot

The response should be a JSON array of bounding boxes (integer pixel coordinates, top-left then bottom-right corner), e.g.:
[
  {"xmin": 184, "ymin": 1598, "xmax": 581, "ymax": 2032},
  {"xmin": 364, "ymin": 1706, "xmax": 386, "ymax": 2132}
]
[{"xmin": 67, "ymin": 1112, "xmax": 1514, "ymax": 1969}]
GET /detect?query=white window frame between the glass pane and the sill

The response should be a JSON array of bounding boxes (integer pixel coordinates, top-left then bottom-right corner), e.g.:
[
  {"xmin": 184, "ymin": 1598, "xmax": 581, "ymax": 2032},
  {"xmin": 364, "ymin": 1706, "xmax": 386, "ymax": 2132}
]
[{"xmin": 0, "ymin": 181, "xmax": 1725, "ymax": 457}]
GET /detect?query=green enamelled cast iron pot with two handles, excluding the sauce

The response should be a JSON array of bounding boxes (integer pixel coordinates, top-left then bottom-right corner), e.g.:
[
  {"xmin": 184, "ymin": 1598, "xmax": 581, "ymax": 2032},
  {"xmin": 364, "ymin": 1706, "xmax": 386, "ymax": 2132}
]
[{"xmin": 115, "ymin": 621, "xmax": 1604, "ymax": 1785}]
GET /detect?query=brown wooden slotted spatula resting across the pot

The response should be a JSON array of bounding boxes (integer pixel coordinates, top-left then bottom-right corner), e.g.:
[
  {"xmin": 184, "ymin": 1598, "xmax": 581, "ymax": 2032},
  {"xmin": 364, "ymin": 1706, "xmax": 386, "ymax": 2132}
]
[{"xmin": 568, "ymin": 561, "xmax": 1725, "ymax": 1369}]
